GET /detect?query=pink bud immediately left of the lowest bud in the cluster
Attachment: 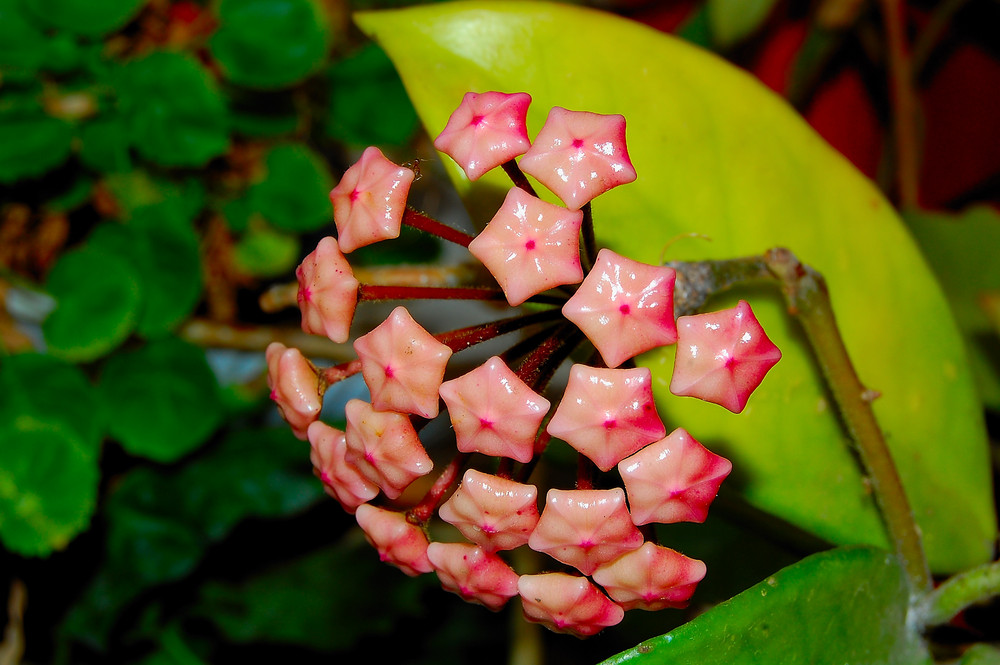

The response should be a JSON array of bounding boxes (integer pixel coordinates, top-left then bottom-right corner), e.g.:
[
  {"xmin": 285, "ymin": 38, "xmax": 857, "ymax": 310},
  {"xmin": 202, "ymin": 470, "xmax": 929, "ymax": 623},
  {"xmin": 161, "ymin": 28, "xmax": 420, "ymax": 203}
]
[{"xmin": 427, "ymin": 543, "xmax": 518, "ymax": 612}]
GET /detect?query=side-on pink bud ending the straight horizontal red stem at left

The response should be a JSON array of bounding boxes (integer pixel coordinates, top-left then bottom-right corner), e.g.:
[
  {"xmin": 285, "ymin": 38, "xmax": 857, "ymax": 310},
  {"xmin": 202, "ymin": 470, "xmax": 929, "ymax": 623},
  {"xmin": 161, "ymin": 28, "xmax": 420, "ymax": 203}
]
[{"xmin": 295, "ymin": 236, "xmax": 358, "ymax": 343}]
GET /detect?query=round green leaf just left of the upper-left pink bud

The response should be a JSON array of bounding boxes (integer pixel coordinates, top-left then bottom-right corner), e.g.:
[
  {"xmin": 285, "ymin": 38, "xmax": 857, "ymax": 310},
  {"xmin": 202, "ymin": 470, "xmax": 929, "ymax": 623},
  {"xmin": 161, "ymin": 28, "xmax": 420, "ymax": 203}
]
[{"xmin": 249, "ymin": 143, "xmax": 333, "ymax": 232}]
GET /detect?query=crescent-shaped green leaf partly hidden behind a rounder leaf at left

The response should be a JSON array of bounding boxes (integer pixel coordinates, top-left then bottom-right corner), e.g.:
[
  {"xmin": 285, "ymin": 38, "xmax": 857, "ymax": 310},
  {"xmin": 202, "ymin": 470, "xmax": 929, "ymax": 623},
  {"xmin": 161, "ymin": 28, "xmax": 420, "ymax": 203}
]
[{"xmin": 87, "ymin": 220, "xmax": 201, "ymax": 337}]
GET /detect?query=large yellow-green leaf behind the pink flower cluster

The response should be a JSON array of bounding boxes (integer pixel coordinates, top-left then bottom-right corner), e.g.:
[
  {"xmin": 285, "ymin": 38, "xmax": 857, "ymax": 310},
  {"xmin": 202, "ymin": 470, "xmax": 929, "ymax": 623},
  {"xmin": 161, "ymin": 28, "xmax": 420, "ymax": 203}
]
[{"xmin": 357, "ymin": 2, "xmax": 996, "ymax": 571}]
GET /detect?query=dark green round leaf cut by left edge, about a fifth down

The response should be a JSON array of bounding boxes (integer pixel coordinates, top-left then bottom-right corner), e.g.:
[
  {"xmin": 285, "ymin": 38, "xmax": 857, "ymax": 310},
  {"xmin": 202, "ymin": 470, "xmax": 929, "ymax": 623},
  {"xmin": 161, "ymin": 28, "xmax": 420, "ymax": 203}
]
[{"xmin": 0, "ymin": 100, "xmax": 73, "ymax": 184}]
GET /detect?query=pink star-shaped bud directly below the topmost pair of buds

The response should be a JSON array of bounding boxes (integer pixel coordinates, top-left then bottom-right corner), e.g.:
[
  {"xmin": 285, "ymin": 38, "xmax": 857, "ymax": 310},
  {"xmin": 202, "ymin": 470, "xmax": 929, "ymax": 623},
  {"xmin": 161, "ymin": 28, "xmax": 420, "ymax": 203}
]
[{"xmin": 469, "ymin": 187, "xmax": 583, "ymax": 306}]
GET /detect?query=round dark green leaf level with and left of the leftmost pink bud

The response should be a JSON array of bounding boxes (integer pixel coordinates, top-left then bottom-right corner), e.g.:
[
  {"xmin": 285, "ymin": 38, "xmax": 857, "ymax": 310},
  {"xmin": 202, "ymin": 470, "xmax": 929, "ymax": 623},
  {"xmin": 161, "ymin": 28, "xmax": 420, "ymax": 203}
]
[{"xmin": 100, "ymin": 337, "xmax": 223, "ymax": 462}]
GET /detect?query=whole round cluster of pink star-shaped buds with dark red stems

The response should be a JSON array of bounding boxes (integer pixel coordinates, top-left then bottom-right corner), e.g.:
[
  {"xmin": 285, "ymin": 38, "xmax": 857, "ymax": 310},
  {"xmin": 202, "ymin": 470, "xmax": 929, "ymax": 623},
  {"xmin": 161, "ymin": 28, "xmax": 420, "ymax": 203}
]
[{"xmin": 267, "ymin": 92, "xmax": 781, "ymax": 636}]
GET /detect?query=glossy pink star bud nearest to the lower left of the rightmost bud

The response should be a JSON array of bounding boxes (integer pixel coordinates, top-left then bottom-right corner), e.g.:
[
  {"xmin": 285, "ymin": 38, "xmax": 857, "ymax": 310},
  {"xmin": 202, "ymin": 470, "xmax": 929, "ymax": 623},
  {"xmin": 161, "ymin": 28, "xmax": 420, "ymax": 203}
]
[{"xmin": 546, "ymin": 365, "xmax": 667, "ymax": 471}]
